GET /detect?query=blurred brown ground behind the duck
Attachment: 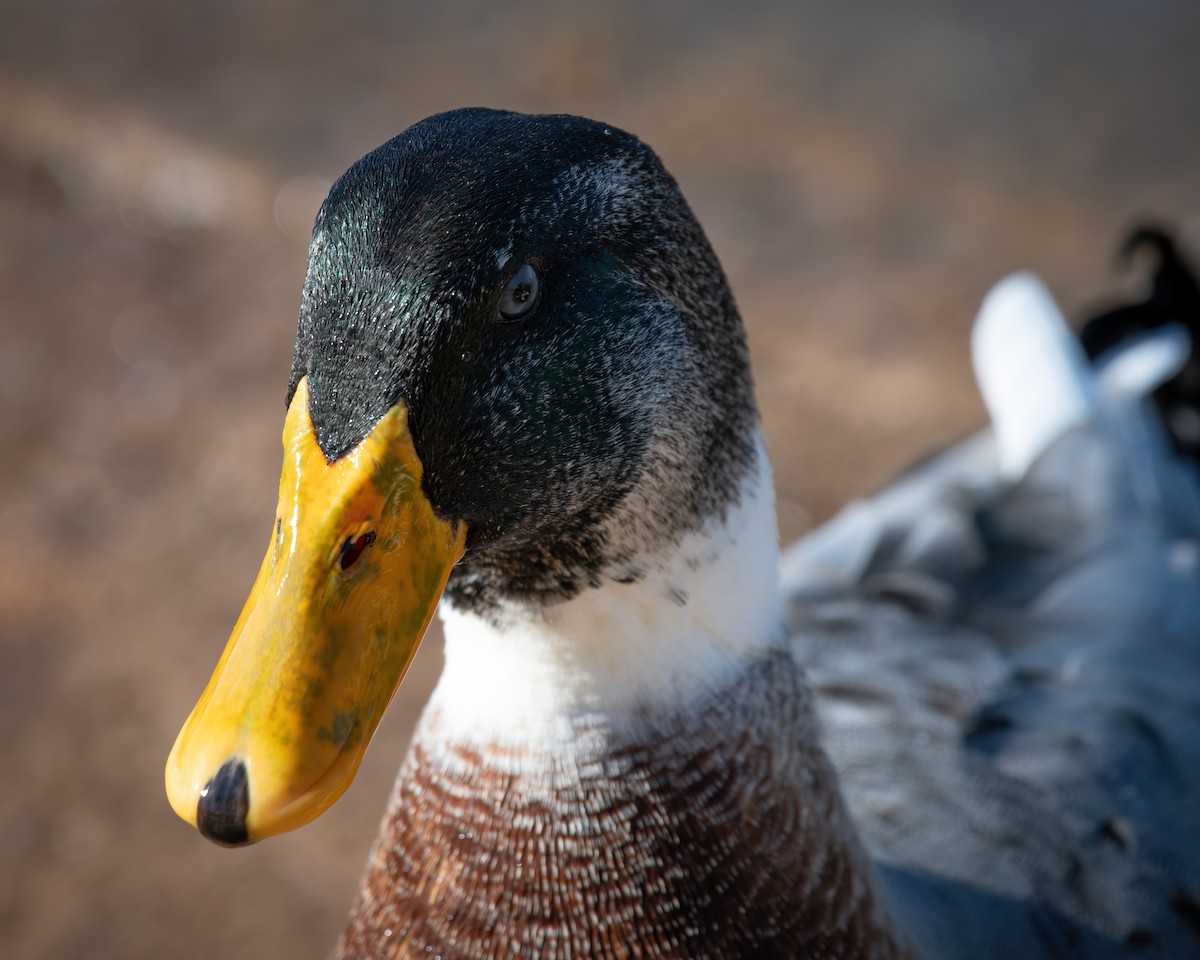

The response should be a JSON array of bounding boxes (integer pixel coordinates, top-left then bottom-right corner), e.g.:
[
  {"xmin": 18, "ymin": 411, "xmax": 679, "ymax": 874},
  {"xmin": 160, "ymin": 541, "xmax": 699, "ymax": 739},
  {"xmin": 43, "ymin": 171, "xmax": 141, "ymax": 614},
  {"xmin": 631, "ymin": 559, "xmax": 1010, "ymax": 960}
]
[{"xmin": 0, "ymin": 0, "xmax": 1200, "ymax": 960}]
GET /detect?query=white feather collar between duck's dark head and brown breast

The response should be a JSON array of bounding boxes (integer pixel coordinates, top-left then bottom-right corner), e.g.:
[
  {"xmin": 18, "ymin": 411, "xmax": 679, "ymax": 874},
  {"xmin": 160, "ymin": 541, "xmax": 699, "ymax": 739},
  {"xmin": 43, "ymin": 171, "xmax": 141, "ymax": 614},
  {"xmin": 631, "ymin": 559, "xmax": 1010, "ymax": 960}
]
[{"xmin": 422, "ymin": 436, "xmax": 782, "ymax": 748}]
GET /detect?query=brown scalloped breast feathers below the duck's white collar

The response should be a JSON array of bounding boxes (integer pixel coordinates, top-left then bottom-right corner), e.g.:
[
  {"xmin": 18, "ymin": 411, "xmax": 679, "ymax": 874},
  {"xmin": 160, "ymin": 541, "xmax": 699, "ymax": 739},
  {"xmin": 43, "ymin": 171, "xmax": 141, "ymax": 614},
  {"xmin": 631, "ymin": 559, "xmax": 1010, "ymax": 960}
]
[{"xmin": 337, "ymin": 652, "xmax": 905, "ymax": 960}]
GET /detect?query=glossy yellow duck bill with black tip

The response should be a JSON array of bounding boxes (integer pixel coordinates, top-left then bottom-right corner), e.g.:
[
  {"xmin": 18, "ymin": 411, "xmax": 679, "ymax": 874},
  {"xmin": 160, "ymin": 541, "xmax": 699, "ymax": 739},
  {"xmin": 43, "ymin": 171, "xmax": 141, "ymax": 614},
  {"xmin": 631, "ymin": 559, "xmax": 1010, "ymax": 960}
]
[{"xmin": 167, "ymin": 379, "xmax": 467, "ymax": 845}]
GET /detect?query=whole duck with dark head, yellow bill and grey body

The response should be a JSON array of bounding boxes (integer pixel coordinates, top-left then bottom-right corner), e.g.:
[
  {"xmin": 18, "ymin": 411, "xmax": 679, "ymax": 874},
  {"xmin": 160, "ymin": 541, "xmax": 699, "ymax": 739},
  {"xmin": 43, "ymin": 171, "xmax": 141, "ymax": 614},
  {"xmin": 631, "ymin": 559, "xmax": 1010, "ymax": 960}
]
[{"xmin": 166, "ymin": 108, "xmax": 1200, "ymax": 960}]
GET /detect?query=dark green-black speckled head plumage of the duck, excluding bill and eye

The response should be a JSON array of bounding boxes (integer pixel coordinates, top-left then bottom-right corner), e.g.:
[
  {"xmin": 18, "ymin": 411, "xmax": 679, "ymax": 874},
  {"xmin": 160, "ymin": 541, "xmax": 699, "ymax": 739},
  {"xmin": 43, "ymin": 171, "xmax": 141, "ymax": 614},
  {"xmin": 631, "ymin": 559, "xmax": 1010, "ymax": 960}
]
[{"xmin": 292, "ymin": 109, "xmax": 757, "ymax": 611}]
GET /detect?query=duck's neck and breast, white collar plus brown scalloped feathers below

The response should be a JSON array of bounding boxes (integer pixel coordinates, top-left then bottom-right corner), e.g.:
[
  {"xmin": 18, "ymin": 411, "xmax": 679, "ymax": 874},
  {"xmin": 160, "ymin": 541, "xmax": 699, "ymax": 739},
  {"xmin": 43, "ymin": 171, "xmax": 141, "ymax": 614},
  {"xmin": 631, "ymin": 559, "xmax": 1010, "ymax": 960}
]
[{"xmin": 338, "ymin": 441, "xmax": 902, "ymax": 960}]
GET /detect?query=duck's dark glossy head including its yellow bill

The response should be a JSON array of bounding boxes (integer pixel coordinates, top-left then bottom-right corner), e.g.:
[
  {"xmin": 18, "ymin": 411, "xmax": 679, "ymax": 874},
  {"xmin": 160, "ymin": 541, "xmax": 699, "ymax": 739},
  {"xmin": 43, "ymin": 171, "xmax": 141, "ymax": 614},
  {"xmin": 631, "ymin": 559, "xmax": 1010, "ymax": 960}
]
[{"xmin": 167, "ymin": 109, "xmax": 757, "ymax": 845}]
